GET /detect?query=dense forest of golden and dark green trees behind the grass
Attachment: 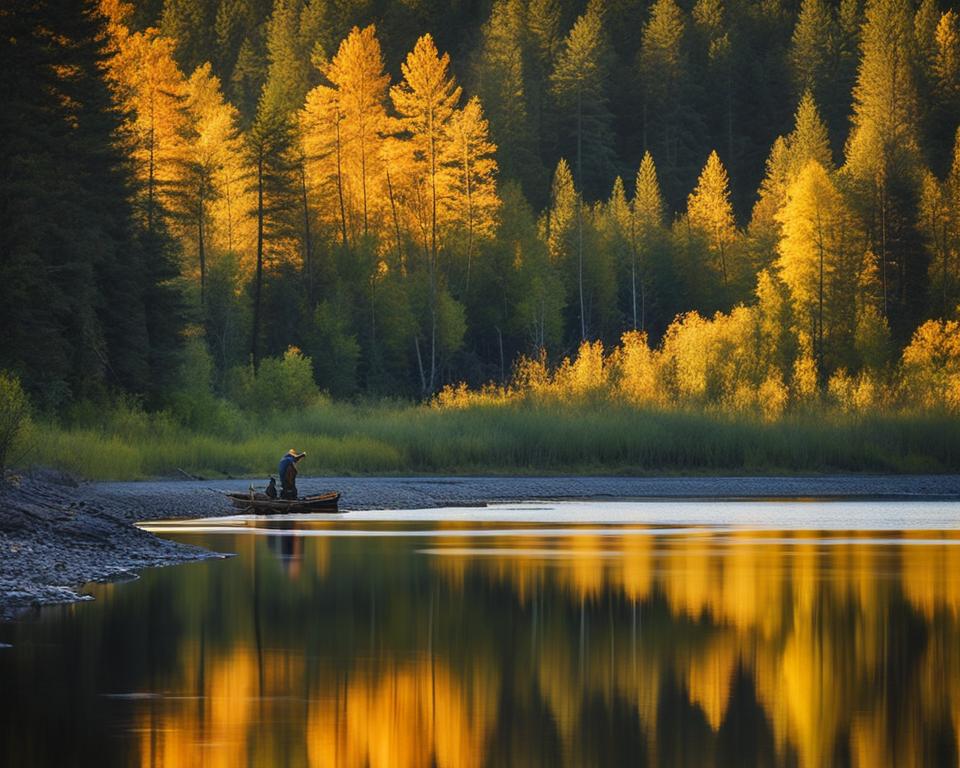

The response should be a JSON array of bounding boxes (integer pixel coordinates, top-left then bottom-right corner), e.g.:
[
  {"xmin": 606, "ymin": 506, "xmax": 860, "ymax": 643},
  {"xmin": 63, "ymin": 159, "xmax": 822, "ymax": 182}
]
[{"xmin": 0, "ymin": 0, "xmax": 960, "ymax": 474}]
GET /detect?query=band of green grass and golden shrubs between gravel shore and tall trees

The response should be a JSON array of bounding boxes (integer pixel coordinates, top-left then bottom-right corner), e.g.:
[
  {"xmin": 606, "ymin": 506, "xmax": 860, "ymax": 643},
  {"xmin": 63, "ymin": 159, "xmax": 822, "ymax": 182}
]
[{"xmin": 7, "ymin": 328, "xmax": 960, "ymax": 480}]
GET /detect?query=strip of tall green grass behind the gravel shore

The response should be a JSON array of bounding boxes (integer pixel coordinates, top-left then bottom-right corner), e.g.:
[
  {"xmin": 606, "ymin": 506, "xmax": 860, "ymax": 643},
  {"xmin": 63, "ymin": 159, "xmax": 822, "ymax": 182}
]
[{"xmin": 25, "ymin": 400, "xmax": 960, "ymax": 480}]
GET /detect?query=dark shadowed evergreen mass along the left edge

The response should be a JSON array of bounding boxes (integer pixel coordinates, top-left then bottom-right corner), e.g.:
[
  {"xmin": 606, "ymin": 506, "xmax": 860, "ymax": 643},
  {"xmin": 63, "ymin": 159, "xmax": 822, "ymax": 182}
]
[{"xmin": 0, "ymin": 2, "xmax": 181, "ymax": 407}]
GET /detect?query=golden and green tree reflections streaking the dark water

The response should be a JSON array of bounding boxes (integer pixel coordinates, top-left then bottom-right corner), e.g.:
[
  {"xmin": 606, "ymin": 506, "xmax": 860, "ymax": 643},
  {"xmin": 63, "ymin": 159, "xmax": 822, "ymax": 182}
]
[{"xmin": 129, "ymin": 525, "xmax": 960, "ymax": 768}]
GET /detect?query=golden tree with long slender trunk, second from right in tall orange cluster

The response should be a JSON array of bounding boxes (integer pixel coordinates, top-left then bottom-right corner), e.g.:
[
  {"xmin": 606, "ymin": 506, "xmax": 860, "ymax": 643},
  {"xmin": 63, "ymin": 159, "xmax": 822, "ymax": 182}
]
[{"xmin": 390, "ymin": 34, "xmax": 461, "ymax": 393}]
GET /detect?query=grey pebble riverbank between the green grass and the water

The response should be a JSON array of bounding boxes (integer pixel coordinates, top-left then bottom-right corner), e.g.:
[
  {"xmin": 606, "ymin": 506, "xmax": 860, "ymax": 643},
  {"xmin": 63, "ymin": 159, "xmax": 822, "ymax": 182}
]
[{"xmin": 0, "ymin": 472, "xmax": 960, "ymax": 620}]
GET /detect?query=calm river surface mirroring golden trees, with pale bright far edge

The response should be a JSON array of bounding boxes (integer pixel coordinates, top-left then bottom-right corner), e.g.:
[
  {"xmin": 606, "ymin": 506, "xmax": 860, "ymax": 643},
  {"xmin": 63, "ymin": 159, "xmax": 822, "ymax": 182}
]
[{"xmin": 0, "ymin": 502, "xmax": 960, "ymax": 768}]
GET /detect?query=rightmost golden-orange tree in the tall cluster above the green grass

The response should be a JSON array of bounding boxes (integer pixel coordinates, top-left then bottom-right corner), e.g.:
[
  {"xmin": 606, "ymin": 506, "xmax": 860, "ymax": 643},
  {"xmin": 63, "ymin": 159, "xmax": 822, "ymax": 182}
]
[{"xmin": 443, "ymin": 96, "xmax": 500, "ymax": 292}]
